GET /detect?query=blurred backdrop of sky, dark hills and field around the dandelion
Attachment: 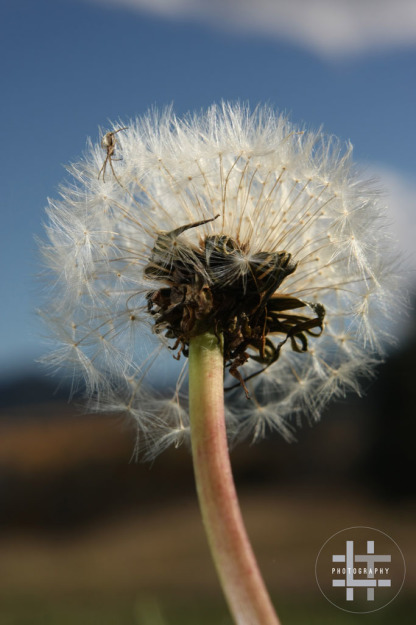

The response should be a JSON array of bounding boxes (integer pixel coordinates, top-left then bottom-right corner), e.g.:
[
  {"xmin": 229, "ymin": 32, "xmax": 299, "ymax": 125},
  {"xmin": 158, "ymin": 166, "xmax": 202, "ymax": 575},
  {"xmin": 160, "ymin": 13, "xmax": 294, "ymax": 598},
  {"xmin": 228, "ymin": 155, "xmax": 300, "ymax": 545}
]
[{"xmin": 0, "ymin": 0, "xmax": 416, "ymax": 625}]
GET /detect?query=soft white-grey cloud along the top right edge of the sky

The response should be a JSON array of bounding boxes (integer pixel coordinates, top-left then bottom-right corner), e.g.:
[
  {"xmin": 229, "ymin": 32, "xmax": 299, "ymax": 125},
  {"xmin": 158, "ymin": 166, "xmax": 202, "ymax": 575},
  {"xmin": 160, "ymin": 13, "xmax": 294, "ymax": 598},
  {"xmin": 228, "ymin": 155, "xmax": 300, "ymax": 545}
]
[{"xmin": 87, "ymin": 0, "xmax": 416, "ymax": 58}]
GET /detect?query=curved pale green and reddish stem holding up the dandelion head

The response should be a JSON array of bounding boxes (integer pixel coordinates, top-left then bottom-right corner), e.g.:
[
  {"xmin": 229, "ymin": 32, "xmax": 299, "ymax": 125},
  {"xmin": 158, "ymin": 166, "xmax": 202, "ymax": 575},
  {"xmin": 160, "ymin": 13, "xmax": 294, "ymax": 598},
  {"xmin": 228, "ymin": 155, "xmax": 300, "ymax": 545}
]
[{"xmin": 189, "ymin": 332, "xmax": 280, "ymax": 625}]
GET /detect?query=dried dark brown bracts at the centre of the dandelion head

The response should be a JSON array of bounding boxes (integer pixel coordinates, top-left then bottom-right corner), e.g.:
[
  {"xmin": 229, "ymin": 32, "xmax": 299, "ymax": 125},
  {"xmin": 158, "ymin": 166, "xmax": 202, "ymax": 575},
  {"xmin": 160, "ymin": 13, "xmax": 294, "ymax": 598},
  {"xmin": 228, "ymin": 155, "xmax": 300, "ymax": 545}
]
[{"xmin": 144, "ymin": 215, "xmax": 325, "ymax": 397}]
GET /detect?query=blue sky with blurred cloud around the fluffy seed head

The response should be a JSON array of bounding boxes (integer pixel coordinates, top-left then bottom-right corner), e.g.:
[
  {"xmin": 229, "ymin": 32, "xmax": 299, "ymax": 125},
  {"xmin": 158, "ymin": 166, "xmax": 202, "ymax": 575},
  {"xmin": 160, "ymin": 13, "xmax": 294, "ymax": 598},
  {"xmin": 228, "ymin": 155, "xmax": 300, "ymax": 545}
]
[{"xmin": 0, "ymin": 0, "xmax": 416, "ymax": 376}]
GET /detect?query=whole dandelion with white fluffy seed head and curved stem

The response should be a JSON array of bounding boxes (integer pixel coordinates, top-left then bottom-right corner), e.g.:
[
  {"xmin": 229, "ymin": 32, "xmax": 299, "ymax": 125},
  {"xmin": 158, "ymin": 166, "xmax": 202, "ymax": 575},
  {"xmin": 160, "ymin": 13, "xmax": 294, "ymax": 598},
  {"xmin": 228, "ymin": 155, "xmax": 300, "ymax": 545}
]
[{"xmin": 42, "ymin": 104, "xmax": 397, "ymax": 624}]
